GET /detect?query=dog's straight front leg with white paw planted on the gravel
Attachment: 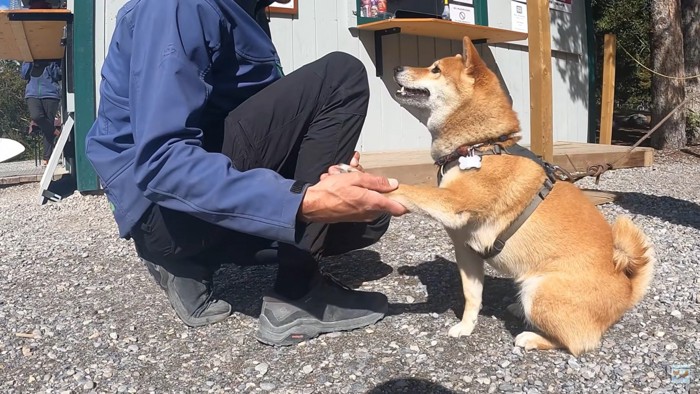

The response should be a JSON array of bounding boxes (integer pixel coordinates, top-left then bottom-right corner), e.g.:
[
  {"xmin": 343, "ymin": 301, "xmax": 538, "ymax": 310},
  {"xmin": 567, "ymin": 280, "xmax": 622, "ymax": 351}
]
[{"xmin": 447, "ymin": 230, "xmax": 484, "ymax": 338}]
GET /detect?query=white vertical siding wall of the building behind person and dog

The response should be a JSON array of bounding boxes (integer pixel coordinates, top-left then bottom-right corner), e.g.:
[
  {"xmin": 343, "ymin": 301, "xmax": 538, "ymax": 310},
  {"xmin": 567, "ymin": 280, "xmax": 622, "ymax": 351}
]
[{"xmin": 95, "ymin": 0, "xmax": 588, "ymax": 152}]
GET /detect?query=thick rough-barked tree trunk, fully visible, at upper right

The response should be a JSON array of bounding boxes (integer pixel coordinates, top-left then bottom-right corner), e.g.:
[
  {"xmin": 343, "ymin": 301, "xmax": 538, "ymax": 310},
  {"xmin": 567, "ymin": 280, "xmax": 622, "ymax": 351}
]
[{"xmin": 651, "ymin": 0, "xmax": 686, "ymax": 149}]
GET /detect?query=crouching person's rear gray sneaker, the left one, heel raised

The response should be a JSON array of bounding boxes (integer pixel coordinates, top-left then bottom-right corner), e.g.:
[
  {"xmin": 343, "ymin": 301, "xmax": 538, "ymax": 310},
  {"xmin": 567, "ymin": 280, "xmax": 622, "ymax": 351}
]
[{"xmin": 141, "ymin": 259, "xmax": 231, "ymax": 327}]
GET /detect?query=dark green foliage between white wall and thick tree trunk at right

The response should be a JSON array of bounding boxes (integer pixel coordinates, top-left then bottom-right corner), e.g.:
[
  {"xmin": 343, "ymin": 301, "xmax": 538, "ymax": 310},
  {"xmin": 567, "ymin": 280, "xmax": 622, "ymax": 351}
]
[{"xmin": 592, "ymin": 0, "xmax": 651, "ymax": 110}]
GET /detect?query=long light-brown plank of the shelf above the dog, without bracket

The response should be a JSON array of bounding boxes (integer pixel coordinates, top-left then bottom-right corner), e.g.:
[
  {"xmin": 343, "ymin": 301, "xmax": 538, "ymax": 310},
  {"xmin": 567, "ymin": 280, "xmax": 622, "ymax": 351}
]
[{"xmin": 357, "ymin": 18, "xmax": 527, "ymax": 43}]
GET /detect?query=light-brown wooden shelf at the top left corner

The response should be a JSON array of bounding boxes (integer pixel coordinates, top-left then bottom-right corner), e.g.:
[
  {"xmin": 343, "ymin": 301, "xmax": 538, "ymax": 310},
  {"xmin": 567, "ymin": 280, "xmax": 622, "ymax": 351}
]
[{"xmin": 0, "ymin": 9, "xmax": 73, "ymax": 62}]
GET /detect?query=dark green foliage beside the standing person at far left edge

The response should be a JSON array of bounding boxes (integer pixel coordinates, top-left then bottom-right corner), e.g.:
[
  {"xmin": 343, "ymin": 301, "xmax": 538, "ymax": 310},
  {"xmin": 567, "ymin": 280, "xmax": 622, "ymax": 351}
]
[{"xmin": 0, "ymin": 60, "xmax": 37, "ymax": 160}]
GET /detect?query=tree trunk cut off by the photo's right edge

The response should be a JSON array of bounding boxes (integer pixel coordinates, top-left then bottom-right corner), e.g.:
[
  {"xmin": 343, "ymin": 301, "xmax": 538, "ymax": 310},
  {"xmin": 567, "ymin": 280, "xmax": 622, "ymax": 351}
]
[{"xmin": 681, "ymin": 0, "xmax": 700, "ymax": 145}]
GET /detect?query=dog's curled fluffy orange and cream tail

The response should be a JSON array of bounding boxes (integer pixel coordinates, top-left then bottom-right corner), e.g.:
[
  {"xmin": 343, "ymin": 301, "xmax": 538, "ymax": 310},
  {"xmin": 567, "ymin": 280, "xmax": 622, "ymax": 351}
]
[{"xmin": 612, "ymin": 216, "xmax": 656, "ymax": 307}]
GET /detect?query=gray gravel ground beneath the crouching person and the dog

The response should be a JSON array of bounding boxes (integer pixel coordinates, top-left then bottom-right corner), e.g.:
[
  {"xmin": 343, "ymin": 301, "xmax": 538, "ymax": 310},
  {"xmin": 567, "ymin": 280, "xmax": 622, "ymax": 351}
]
[{"xmin": 0, "ymin": 149, "xmax": 700, "ymax": 393}]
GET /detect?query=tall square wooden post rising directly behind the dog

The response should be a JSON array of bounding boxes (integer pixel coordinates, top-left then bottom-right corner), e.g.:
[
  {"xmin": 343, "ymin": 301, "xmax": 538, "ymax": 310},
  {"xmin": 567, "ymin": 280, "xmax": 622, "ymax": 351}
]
[{"xmin": 527, "ymin": 0, "xmax": 554, "ymax": 162}]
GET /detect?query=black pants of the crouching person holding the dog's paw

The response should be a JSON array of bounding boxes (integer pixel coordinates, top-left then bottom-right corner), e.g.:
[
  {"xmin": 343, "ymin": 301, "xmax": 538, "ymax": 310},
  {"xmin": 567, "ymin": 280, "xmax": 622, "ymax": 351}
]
[{"xmin": 132, "ymin": 53, "xmax": 389, "ymax": 296}]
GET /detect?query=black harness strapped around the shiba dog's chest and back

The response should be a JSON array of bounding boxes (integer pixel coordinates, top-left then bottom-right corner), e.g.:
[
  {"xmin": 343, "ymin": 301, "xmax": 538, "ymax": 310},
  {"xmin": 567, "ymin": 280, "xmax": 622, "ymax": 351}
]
[{"xmin": 435, "ymin": 140, "xmax": 557, "ymax": 259}]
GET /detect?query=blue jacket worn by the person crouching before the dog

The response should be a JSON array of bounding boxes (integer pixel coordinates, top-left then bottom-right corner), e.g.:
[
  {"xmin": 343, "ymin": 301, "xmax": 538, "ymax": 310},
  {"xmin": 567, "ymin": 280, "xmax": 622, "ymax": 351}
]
[{"xmin": 86, "ymin": 0, "xmax": 303, "ymax": 242}]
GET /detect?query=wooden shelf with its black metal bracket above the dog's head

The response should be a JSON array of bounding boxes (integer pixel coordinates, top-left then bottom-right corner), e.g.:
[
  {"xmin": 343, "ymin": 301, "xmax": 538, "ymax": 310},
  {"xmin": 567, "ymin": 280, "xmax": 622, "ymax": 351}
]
[{"xmin": 357, "ymin": 18, "xmax": 527, "ymax": 77}]
